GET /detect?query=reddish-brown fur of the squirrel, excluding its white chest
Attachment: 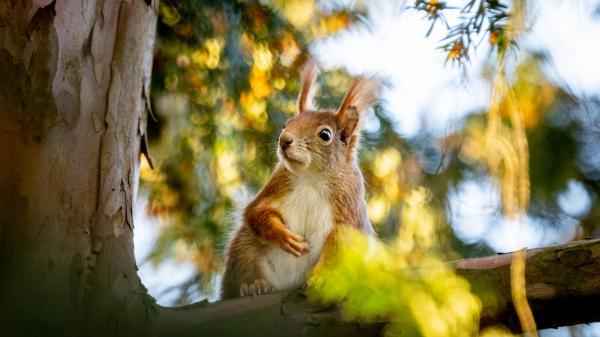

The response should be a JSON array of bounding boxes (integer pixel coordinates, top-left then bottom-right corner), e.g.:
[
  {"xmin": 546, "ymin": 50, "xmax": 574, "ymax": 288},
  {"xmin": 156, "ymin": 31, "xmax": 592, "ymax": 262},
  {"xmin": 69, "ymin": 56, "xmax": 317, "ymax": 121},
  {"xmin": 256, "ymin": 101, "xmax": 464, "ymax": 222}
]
[{"xmin": 221, "ymin": 63, "xmax": 378, "ymax": 298}]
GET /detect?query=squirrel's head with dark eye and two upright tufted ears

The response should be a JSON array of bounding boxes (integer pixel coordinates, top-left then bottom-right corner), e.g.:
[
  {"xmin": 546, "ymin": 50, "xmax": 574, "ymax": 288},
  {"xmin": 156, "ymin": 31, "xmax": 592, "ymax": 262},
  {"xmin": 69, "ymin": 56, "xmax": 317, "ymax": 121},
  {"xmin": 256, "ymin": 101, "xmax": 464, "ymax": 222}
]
[{"xmin": 277, "ymin": 61, "xmax": 379, "ymax": 172}]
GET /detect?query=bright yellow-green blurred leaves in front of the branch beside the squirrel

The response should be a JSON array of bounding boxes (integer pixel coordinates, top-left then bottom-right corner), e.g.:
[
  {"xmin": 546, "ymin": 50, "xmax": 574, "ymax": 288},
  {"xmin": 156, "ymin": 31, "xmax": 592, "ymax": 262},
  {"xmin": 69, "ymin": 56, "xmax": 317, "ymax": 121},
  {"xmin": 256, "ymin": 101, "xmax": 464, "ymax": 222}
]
[{"xmin": 308, "ymin": 188, "xmax": 481, "ymax": 337}]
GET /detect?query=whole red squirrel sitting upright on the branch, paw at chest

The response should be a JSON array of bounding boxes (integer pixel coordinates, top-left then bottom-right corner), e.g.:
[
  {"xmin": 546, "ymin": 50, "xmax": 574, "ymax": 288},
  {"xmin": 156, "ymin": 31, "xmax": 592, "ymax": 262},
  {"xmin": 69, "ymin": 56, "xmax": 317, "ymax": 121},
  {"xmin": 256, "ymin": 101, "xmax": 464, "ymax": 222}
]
[{"xmin": 221, "ymin": 61, "xmax": 379, "ymax": 299}]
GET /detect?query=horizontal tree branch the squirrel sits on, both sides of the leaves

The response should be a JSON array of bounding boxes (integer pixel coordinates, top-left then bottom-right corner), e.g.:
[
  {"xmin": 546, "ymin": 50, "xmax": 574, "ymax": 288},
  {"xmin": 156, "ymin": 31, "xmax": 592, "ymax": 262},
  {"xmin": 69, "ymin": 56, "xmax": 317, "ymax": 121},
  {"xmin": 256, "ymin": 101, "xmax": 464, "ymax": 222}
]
[{"xmin": 158, "ymin": 240, "xmax": 600, "ymax": 336}]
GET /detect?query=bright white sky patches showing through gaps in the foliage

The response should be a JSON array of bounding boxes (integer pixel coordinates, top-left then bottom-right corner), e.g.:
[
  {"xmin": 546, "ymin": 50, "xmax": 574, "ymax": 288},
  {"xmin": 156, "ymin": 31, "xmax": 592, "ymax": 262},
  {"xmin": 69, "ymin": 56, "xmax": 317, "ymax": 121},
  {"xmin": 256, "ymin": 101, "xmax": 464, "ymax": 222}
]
[{"xmin": 134, "ymin": 0, "xmax": 600, "ymax": 337}]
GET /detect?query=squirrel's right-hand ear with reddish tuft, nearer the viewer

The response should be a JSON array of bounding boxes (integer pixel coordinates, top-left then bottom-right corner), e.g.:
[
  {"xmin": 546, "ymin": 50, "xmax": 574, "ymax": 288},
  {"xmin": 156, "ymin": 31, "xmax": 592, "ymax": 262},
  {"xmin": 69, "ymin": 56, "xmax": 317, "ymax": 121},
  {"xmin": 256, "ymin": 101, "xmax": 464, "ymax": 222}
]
[{"xmin": 335, "ymin": 76, "xmax": 381, "ymax": 145}]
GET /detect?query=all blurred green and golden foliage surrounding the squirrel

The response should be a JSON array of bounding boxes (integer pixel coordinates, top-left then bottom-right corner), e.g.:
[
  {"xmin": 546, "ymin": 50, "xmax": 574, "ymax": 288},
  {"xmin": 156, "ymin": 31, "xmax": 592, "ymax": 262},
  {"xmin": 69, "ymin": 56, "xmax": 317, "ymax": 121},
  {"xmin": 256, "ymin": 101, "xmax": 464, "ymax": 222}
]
[{"xmin": 141, "ymin": 4, "xmax": 600, "ymax": 336}]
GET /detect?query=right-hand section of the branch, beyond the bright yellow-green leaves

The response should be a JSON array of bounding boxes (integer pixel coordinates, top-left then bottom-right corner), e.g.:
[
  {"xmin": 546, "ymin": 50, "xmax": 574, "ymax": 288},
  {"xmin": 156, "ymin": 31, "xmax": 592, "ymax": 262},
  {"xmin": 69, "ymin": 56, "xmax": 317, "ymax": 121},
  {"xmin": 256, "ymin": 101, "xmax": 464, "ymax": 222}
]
[{"xmin": 453, "ymin": 240, "xmax": 600, "ymax": 331}]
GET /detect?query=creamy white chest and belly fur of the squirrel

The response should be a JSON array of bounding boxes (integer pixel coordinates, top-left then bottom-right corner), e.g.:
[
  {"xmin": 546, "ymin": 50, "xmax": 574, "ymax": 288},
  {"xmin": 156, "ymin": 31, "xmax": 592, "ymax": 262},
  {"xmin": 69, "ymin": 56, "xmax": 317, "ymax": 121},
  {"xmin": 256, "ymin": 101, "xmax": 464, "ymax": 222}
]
[{"xmin": 260, "ymin": 178, "xmax": 333, "ymax": 289}]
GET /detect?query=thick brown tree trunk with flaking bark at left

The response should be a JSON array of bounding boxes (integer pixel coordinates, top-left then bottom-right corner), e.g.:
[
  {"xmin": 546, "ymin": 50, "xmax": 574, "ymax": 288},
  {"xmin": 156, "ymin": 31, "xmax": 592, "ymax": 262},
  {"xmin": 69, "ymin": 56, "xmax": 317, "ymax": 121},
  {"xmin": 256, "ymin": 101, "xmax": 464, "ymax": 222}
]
[{"xmin": 0, "ymin": 0, "xmax": 157, "ymax": 336}]
